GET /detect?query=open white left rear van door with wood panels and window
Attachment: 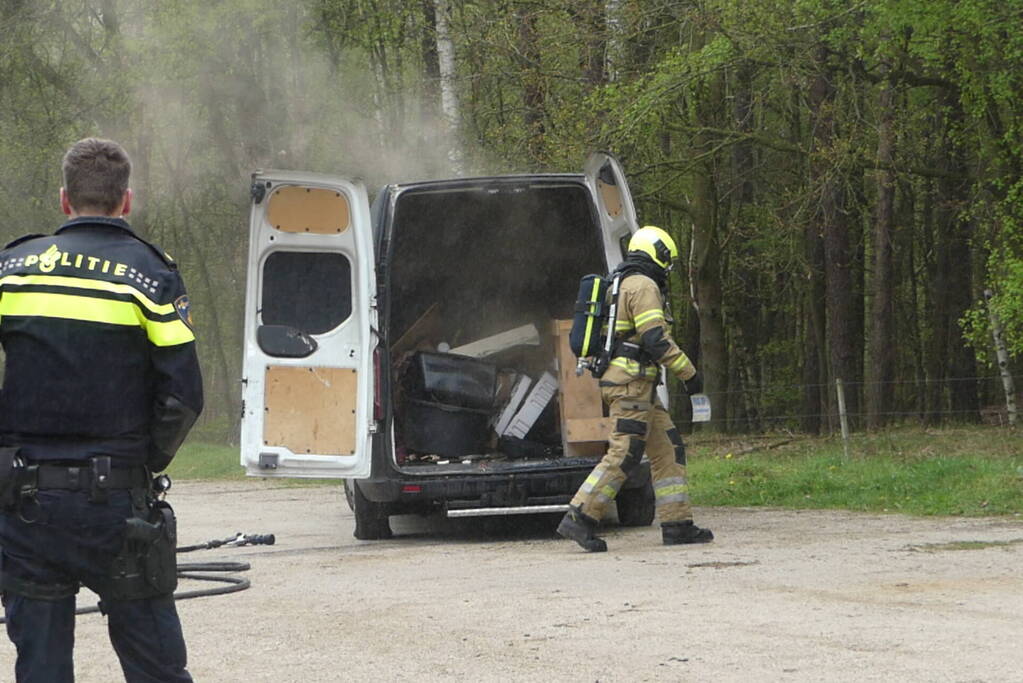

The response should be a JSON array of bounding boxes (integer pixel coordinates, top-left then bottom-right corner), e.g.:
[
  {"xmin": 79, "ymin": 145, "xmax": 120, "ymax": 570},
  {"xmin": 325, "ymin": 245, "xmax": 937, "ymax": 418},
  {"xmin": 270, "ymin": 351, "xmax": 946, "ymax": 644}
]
[{"xmin": 241, "ymin": 171, "xmax": 376, "ymax": 479}]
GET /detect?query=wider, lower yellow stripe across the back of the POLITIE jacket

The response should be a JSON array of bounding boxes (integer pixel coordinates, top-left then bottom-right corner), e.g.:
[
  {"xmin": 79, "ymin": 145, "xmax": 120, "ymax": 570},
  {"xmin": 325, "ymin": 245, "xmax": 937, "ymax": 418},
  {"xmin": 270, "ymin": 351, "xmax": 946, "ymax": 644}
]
[{"xmin": 0, "ymin": 291, "xmax": 195, "ymax": 347}]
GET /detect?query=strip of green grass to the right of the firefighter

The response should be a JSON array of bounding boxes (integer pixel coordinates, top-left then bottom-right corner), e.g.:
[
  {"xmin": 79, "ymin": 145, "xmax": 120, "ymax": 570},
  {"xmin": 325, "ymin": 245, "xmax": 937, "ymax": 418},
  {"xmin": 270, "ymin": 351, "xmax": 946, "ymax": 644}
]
[{"xmin": 690, "ymin": 426, "xmax": 1023, "ymax": 515}]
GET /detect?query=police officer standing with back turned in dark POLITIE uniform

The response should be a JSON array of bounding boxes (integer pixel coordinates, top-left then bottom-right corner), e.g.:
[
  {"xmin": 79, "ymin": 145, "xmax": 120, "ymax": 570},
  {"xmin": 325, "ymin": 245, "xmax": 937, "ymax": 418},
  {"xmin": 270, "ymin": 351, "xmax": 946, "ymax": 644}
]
[{"xmin": 0, "ymin": 138, "xmax": 203, "ymax": 683}]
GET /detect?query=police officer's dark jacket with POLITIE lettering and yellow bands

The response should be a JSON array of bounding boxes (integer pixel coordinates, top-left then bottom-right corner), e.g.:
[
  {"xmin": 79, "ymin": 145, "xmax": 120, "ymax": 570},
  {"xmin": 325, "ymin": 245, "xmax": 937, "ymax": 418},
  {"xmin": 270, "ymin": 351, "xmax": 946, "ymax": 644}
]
[{"xmin": 0, "ymin": 217, "xmax": 203, "ymax": 464}]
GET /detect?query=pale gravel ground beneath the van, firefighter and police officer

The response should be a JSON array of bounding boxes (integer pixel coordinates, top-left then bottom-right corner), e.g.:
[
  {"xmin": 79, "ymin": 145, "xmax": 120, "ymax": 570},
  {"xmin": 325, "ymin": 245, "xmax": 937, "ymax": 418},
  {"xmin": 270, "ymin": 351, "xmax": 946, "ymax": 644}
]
[{"xmin": 0, "ymin": 481, "xmax": 1023, "ymax": 682}]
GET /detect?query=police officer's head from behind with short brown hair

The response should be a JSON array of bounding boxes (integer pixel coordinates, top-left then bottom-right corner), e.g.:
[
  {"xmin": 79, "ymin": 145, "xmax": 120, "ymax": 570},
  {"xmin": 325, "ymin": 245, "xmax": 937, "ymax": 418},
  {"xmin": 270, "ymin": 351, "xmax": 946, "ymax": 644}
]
[{"xmin": 61, "ymin": 138, "xmax": 131, "ymax": 215}]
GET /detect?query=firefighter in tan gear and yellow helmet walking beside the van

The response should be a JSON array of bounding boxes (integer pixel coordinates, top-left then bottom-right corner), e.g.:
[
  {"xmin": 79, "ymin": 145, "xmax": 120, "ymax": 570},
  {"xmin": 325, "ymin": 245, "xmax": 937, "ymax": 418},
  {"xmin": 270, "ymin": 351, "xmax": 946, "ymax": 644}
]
[{"xmin": 558, "ymin": 226, "xmax": 714, "ymax": 552}]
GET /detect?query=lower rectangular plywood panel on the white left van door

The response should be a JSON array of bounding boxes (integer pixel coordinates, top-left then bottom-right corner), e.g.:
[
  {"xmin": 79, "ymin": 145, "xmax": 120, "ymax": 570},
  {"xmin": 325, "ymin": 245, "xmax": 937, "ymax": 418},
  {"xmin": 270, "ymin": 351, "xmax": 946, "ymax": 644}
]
[{"xmin": 263, "ymin": 366, "xmax": 358, "ymax": 455}]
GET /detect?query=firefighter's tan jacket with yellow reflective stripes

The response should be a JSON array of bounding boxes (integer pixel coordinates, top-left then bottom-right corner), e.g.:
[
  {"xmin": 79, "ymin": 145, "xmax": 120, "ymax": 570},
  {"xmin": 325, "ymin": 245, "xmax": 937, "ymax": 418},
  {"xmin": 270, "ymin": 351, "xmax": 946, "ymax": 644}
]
[{"xmin": 601, "ymin": 273, "xmax": 697, "ymax": 384}]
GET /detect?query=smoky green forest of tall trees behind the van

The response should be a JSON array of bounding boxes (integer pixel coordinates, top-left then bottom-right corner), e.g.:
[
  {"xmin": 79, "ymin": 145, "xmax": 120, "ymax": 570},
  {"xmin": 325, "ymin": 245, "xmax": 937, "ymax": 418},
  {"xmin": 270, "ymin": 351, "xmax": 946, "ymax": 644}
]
[{"xmin": 0, "ymin": 0, "xmax": 1023, "ymax": 441}]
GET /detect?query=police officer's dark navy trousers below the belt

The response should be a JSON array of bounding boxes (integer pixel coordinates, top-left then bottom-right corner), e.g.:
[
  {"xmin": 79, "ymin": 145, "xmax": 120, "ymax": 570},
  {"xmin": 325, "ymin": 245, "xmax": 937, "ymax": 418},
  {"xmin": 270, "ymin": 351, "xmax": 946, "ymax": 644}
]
[{"xmin": 0, "ymin": 490, "xmax": 192, "ymax": 683}]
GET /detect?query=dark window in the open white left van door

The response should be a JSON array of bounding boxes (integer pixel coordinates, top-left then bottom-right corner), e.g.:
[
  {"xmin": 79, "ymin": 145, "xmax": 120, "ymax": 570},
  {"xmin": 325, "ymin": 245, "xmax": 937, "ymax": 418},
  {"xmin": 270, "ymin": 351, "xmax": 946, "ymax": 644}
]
[{"xmin": 260, "ymin": 252, "xmax": 352, "ymax": 334}]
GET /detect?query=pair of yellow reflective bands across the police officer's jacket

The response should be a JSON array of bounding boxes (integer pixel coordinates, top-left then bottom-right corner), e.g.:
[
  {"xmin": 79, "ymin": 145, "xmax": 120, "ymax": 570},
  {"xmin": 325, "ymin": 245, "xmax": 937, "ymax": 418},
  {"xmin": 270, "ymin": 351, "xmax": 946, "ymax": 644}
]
[{"xmin": 0, "ymin": 275, "xmax": 195, "ymax": 347}]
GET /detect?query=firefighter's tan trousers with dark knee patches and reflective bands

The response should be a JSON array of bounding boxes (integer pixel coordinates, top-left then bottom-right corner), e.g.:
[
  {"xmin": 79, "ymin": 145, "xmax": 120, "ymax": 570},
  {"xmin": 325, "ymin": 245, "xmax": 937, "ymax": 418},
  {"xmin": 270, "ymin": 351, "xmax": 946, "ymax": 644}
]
[{"xmin": 571, "ymin": 378, "xmax": 693, "ymax": 523}]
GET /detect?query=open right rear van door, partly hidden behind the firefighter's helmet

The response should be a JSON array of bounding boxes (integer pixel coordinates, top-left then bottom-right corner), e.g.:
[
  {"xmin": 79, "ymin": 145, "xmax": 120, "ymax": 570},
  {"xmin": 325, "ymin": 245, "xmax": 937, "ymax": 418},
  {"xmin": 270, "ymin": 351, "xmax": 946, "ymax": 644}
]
[{"xmin": 583, "ymin": 151, "xmax": 639, "ymax": 269}]
